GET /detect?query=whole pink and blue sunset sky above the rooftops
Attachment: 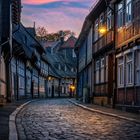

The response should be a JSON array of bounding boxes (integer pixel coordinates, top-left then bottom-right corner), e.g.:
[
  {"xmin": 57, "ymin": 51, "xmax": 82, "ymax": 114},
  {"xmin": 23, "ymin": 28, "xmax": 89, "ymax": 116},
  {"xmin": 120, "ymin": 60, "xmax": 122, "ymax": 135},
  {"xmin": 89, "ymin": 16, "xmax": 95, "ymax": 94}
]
[{"xmin": 22, "ymin": 0, "xmax": 91, "ymax": 35}]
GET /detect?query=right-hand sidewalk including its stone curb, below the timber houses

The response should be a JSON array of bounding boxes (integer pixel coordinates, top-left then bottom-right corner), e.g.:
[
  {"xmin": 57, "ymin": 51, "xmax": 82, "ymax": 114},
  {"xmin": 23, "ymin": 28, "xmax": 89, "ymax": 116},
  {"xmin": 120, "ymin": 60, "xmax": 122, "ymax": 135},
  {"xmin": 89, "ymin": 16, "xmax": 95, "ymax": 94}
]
[{"xmin": 69, "ymin": 99, "xmax": 140, "ymax": 123}]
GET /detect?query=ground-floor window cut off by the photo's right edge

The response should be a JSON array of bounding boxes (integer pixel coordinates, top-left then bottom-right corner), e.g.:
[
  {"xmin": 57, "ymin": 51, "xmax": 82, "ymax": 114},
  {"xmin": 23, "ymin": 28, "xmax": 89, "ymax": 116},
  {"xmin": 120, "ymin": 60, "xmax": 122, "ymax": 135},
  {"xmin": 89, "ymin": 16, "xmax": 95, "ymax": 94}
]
[{"xmin": 136, "ymin": 51, "xmax": 140, "ymax": 85}]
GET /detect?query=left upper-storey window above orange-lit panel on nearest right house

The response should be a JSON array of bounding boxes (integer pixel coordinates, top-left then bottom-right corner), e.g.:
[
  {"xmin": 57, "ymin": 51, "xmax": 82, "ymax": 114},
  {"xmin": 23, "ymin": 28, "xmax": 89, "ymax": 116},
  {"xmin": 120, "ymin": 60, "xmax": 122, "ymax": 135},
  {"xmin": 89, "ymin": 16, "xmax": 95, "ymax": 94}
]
[{"xmin": 117, "ymin": 1, "xmax": 123, "ymax": 27}]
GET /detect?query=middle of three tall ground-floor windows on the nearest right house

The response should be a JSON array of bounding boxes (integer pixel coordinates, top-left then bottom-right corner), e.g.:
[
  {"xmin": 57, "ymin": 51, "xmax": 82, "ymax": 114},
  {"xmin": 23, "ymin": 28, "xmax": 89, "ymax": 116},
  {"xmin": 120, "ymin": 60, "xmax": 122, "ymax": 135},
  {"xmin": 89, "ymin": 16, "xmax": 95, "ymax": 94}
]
[{"xmin": 126, "ymin": 53, "xmax": 133, "ymax": 85}]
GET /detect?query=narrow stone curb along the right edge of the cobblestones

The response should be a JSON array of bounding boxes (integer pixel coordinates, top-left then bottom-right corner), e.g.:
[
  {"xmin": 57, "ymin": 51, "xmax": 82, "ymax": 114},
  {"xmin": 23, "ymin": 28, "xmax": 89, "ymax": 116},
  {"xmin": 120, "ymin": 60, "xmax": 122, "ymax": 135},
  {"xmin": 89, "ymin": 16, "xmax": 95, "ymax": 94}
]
[{"xmin": 68, "ymin": 100, "xmax": 140, "ymax": 123}]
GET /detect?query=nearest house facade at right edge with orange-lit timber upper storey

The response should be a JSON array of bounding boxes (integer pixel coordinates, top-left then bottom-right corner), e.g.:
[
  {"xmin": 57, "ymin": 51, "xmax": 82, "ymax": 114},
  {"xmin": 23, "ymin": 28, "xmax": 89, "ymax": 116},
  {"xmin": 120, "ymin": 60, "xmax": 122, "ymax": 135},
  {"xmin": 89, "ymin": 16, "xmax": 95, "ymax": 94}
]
[{"xmin": 114, "ymin": 0, "xmax": 140, "ymax": 107}]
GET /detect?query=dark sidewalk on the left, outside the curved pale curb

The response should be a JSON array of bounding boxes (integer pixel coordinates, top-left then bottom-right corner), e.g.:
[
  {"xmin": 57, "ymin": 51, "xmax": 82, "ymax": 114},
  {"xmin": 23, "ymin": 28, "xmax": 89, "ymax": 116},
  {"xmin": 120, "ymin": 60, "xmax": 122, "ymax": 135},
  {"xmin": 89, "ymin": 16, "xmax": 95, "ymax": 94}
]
[{"xmin": 0, "ymin": 100, "xmax": 29, "ymax": 140}]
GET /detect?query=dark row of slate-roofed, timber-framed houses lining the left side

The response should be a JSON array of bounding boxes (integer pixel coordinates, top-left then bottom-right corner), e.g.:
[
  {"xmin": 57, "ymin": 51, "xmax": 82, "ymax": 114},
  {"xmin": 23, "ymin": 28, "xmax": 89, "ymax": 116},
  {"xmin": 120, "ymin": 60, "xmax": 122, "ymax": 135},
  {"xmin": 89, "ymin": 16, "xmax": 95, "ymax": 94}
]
[{"xmin": 0, "ymin": 0, "xmax": 48, "ymax": 103}]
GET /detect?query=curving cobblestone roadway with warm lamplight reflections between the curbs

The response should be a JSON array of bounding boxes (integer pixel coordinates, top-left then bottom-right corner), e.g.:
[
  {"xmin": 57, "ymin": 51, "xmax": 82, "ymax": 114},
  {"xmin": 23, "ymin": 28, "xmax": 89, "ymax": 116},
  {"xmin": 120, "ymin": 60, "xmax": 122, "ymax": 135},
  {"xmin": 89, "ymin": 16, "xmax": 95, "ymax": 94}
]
[{"xmin": 16, "ymin": 99, "xmax": 140, "ymax": 140}]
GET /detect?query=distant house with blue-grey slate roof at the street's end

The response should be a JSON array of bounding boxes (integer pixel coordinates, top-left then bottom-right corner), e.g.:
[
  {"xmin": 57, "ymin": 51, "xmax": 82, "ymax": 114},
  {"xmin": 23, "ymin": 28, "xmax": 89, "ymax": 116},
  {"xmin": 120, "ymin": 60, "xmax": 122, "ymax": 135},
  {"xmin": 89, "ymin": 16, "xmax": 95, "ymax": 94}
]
[{"xmin": 42, "ymin": 36, "xmax": 76, "ymax": 97}]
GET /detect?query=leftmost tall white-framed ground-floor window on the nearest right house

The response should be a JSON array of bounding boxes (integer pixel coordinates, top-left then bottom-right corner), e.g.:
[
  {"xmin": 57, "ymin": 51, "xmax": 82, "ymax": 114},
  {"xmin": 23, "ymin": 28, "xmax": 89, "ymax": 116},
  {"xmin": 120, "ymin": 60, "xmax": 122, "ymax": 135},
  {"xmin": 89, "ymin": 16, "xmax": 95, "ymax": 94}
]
[{"xmin": 118, "ymin": 57, "xmax": 124, "ymax": 87}]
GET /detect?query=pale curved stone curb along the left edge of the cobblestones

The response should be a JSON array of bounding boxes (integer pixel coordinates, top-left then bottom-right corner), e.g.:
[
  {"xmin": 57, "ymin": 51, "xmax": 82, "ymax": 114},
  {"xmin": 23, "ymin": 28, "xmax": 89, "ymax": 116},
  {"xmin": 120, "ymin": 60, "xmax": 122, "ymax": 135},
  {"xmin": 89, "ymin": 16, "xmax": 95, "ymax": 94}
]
[{"xmin": 9, "ymin": 100, "xmax": 36, "ymax": 140}]
